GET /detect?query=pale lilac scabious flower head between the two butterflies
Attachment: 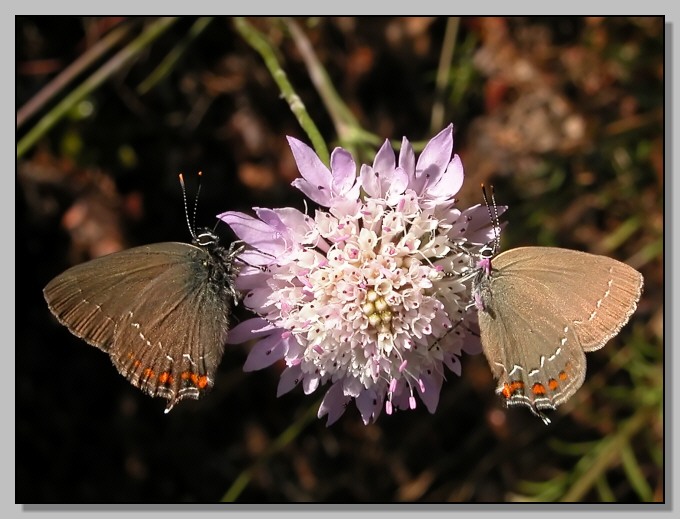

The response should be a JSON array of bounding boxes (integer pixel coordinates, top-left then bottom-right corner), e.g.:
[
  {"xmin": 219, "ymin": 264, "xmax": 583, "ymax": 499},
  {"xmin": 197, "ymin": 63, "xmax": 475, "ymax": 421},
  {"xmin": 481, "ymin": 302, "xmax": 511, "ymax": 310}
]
[{"xmin": 219, "ymin": 125, "xmax": 492, "ymax": 424}]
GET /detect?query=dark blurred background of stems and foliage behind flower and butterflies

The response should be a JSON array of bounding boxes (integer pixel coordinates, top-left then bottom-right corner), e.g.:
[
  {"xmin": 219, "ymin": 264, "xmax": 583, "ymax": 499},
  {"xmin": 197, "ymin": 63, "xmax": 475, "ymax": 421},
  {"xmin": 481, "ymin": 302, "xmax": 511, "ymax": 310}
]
[{"xmin": 15, "ymin": 17, "xmax": 665, "ymax": 503}]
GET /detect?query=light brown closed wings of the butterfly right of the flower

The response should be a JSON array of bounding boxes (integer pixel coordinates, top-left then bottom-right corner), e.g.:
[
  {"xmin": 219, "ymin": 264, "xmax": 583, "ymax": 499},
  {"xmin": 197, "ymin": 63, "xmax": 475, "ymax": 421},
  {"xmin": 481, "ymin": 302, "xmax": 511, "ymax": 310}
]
[{"xmin": 479, "ymin": 247, "xmax": 642, "ymax": 420}]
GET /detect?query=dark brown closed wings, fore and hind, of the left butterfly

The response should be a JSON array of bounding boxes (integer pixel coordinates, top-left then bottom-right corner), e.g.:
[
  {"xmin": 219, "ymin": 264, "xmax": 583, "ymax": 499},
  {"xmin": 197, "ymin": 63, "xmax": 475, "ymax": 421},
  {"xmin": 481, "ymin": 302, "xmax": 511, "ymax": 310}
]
[{"xmin": 44, "ymin": 243, "xmax": 230, "ymax": 411}]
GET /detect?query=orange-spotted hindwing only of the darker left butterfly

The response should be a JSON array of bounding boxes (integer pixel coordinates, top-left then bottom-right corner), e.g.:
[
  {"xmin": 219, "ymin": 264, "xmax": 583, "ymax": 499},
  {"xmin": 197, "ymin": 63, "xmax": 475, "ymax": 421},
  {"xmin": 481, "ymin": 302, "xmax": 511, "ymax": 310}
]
[{"xmin": 111, "ymin": 248, "xmax": 231, "ymax": 411}]
